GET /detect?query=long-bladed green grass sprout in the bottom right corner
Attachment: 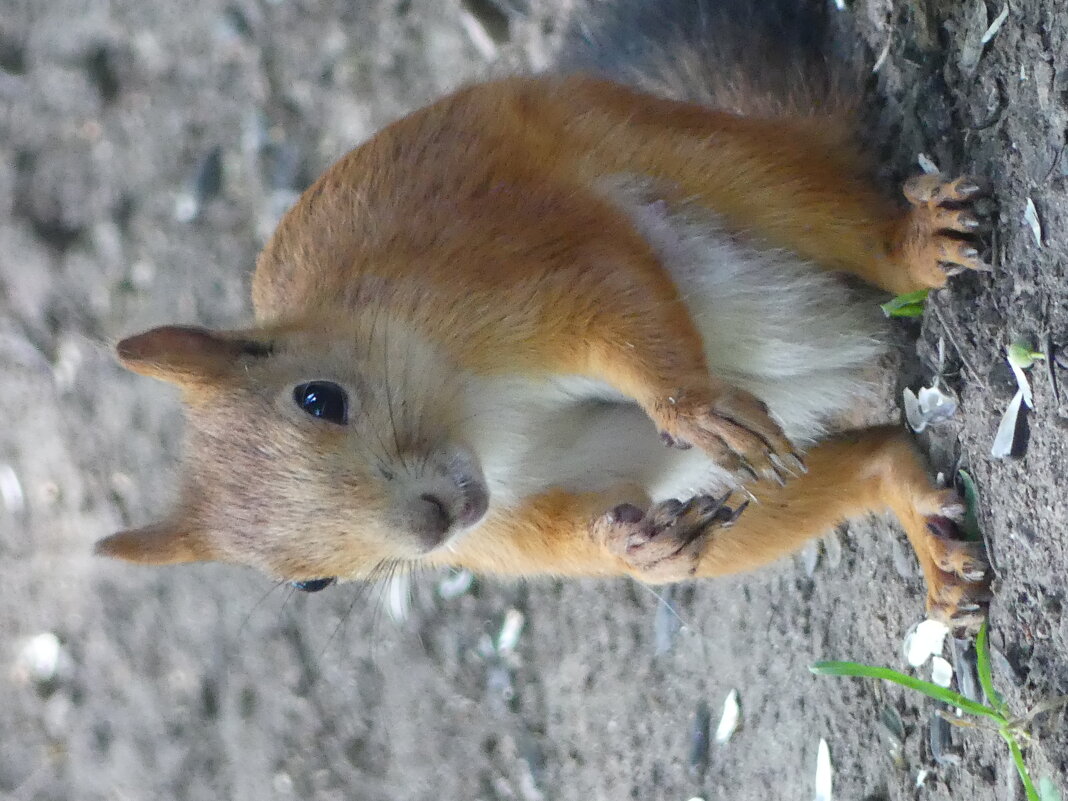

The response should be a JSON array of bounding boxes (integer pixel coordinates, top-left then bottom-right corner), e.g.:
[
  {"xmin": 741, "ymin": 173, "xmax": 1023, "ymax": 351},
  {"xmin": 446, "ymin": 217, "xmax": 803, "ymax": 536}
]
[{"xmin": 808, "ymin": 622, "xmax": 1068, "ymax": 801}]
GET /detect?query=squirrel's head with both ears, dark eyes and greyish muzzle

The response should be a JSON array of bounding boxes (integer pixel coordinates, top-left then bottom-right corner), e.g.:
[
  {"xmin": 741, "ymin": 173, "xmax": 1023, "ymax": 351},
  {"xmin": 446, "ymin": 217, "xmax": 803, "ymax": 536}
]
[{"xmin": 96, "ymin": 315, "xmax": 489, "ymax": 582}]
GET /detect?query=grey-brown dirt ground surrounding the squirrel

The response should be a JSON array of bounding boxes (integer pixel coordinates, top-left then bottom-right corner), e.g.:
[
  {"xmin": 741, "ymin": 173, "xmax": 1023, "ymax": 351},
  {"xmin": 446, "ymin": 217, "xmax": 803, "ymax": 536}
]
[{"xmin": 0, "ymin": 0, "xmax": 1068, "ymax": 801}]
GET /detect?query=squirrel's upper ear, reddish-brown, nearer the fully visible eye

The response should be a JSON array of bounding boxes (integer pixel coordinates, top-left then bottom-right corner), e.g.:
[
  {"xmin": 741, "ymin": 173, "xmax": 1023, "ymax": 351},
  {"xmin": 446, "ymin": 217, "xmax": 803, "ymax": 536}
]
[{"xmin": 115, "ymin": 326, "xmax": 271, "ymax": 386}]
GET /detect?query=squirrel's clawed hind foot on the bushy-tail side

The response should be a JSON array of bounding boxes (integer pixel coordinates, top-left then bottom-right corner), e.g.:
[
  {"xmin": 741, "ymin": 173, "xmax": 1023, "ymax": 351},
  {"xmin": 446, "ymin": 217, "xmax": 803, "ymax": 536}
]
[{"xmin": 894, "ymin": 174, "xmax": 990, "ymax": 288}]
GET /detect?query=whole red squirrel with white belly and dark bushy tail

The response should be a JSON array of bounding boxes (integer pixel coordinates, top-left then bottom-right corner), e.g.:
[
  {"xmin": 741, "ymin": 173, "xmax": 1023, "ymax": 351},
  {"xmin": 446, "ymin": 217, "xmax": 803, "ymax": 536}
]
[{"xmin": 97, "ymin": 0, "xmax": 990, "ymax": 630}]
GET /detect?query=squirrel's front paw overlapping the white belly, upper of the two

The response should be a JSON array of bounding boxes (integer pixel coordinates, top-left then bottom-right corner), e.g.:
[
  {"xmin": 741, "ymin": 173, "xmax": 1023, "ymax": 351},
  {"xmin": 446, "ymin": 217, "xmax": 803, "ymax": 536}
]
[{"xmin": 655, "ymin": 387, "xmax": 805, "ymax": 484}]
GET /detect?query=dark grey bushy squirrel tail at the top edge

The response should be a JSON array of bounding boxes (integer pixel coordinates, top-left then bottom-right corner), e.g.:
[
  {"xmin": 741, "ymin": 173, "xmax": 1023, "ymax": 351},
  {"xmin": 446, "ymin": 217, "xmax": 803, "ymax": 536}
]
[{"xmin": 559, "ymin": 0, "xmax": 860, "ymax": 117}]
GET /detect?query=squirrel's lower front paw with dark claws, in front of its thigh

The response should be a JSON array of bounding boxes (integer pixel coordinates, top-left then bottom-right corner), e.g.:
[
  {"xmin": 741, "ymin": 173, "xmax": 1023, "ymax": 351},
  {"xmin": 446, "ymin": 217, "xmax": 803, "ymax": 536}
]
[{"xmin": 594, "ymin": 493, "xmax": 749, "ymax": 584}]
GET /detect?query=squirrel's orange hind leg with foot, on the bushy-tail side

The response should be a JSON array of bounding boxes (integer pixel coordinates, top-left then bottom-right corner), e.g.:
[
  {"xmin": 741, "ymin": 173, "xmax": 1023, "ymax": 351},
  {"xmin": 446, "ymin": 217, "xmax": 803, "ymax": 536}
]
[{"xmin": 589, "ymin": 107, "xmax": 985, "ymax": 294}]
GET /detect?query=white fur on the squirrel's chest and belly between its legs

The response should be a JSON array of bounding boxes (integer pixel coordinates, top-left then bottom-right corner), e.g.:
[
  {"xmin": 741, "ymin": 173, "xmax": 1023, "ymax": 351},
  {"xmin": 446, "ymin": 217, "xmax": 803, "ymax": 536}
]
[{"xmin": 468, "ymin": 187, "xmax": 885, "ymax": 508}]
